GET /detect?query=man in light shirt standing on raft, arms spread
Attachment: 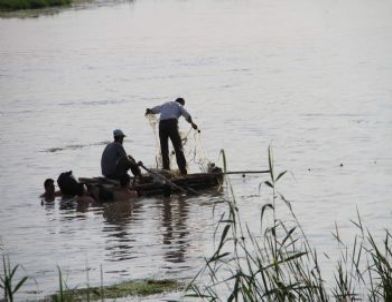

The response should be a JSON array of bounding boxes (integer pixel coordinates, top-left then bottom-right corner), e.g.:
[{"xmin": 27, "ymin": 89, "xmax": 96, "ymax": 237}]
[{"xmin": 146, "ymin": 98, "xmax": 197, "ymax": 175}]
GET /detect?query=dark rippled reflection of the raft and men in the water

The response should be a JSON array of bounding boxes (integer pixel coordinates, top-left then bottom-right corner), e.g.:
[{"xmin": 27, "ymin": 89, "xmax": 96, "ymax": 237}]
[{"xmin": 42, "ymin": 196, "xmax": 195, "ymax": 263}]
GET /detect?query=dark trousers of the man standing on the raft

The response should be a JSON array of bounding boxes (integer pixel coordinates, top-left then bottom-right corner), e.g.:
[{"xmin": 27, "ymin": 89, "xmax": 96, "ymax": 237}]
[{"xmin": 159, "ymin": 119, "xmax": 187, "ymax": 174}]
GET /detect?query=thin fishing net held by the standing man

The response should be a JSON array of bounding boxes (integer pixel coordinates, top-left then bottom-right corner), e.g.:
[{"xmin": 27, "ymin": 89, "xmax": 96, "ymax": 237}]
[{"xmin": 146, "ymin": 114, "xmax": 210, "ymax": 173}]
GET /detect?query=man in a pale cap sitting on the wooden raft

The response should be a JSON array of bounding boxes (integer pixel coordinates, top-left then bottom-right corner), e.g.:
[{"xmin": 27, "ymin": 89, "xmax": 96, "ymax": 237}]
[{"xmin": 101, "ymin": 129, "xmax": 142, "ymax": 180}]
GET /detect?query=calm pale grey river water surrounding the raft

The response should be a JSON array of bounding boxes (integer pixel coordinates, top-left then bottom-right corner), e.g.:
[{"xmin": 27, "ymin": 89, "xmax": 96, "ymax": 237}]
[{"xmin": 0, "ymin": 0, "xmax": 392, "ymax": 300}]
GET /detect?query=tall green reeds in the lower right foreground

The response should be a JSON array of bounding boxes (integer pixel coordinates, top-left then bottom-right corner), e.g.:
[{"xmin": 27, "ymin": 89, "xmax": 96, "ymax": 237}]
[{"xmin": 186, "ymin": 148, "xmax": 392, "ymax": 302}]
